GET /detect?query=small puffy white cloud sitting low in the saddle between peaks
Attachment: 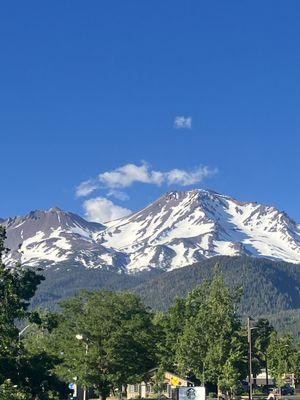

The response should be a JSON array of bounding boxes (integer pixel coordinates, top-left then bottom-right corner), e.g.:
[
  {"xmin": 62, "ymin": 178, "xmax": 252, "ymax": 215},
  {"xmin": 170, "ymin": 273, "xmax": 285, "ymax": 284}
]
[{"xmin": 83, "ymin": 197, "xmax": 132, "ymax": 223}]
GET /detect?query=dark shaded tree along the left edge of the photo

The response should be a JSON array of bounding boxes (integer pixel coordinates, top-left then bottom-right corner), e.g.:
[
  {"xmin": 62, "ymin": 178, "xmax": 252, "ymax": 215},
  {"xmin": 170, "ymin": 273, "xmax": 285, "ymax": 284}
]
[{"xmin": 0, "ymin": 226, "xmax": 65, "ymax": 400}]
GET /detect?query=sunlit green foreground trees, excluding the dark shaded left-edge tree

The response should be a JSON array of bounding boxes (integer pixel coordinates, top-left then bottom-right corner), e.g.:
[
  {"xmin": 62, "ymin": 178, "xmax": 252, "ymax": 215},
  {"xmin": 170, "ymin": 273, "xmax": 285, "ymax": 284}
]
[{"xmin": 27, "ymin": 273, "xmax": 300, "ymax": 398}]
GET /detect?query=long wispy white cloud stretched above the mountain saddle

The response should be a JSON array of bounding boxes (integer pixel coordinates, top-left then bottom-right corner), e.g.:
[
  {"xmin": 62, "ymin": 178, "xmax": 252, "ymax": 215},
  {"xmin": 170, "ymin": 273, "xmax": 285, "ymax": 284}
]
[{"xmin": 76, "ymin": 163, "xmax": 217, "ymax": 196}]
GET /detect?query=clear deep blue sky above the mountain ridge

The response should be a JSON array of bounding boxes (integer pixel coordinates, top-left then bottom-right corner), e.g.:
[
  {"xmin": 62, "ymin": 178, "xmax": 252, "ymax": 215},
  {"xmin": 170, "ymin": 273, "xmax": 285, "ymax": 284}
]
[{"xmin": 0, "ymin": 0, "xmax": 300, "ymax": 221}]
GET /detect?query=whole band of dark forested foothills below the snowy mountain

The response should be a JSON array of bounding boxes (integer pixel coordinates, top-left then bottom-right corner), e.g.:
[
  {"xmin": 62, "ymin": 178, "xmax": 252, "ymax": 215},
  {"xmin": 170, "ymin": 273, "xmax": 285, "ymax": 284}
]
[{"xmin": 32, "ymin": 256, "xmax": 300, "ymax": 335}]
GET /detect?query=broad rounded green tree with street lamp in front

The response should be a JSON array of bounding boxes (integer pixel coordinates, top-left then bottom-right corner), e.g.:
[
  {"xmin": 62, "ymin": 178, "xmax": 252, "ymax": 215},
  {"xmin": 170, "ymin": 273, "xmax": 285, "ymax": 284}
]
[{"xmin": 50, "ymin": 291, "xmax": 156, "ymax": 399}]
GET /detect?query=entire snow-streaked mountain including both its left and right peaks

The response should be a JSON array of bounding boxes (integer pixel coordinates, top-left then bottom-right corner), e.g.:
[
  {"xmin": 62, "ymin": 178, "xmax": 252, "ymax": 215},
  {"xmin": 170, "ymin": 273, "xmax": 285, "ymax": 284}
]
[{"xmin": 4, "ymin": 189, "xmax": 300, "ymax": 273}]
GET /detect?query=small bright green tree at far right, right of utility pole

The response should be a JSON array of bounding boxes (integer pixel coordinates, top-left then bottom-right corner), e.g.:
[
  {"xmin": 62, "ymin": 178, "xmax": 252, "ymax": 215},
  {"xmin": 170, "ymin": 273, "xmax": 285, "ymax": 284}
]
[{"xmin": 268, "ymin": 332, "xmax": 298, "ymax": 386}]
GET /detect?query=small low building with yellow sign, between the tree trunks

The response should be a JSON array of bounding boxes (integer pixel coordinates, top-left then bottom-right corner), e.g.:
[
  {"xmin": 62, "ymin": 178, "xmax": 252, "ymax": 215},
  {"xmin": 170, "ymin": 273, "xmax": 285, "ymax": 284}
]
[{"xmin": 127, "ymin": 368, "xmax": 194, "ymax": 400}]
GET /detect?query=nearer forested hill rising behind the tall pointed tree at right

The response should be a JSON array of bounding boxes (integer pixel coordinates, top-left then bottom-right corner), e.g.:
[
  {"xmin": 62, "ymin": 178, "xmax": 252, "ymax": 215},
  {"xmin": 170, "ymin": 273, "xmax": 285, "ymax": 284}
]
[{"xmin": 134, "ymin": 256, "xmax": 300, "ymax": 316}]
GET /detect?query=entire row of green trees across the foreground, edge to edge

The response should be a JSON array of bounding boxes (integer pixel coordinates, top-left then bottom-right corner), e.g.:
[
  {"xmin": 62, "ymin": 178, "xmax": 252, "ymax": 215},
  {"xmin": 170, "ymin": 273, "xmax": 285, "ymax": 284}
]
[{"xmin": 0, "ymin": 228, "xmax": 300, "ymax": 400}]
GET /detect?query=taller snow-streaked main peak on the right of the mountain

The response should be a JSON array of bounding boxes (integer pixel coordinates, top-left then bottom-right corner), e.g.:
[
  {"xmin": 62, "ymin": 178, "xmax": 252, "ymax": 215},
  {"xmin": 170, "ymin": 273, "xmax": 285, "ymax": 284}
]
[{"xmin": 97, "ymin": 190, "xmax": 300, "ymax": 272}]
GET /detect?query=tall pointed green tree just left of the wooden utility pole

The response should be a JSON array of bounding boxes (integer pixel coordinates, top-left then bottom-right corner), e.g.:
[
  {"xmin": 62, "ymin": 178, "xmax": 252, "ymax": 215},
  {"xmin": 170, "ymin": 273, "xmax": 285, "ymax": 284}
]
[{"xmin": 167, "ymin": 274, "xmax": 247, "ymax": 394}]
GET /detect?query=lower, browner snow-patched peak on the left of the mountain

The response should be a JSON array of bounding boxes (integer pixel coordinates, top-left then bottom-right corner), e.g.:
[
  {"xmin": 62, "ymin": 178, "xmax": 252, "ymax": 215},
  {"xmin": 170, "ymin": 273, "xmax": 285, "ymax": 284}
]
[{"xmin": 3, "ymin": 208, "xmax": 124, "ymax": 268}]
